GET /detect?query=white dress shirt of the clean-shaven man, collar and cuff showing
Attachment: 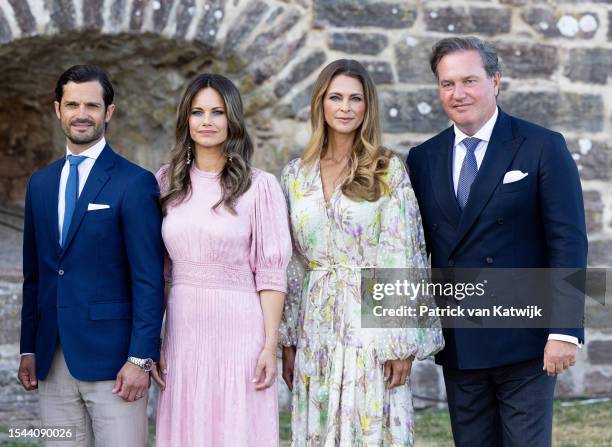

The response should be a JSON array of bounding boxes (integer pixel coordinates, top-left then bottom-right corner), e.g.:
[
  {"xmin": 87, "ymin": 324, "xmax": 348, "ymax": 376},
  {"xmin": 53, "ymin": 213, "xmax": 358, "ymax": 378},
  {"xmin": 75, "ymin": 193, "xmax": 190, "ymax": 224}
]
[{"xmin": 453, "ymin": 107, "xmax": 582, "ymax": 348}]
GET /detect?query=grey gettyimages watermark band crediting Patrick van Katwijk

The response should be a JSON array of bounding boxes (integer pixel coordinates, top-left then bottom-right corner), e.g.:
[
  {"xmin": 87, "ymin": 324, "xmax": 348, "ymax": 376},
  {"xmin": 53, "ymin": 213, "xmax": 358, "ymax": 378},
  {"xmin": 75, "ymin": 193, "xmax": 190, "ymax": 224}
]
[{"xmin": 361, "ymin": 268, "xmax": 612, "ymax": 328}]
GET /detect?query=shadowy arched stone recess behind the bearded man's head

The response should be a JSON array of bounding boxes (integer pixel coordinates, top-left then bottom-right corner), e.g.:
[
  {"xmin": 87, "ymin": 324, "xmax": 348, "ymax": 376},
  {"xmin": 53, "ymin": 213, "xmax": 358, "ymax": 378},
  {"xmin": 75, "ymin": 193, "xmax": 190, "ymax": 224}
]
[{"xmin": 0, "ymin": 32, "xmax": 268, "ymax": 205}]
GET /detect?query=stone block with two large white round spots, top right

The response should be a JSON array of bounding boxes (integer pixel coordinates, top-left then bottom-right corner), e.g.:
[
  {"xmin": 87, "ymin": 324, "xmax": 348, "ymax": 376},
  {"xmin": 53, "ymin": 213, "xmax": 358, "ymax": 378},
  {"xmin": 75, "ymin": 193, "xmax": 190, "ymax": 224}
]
[{"xmin": 521, "ymin": 6, "xmax": 601, "ymax": 39}]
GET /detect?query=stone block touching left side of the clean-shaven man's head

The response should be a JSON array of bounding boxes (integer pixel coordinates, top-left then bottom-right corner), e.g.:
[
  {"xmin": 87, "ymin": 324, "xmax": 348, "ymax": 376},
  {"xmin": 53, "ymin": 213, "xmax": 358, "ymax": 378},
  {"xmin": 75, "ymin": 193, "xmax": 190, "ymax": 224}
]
[{"xmin": 395, "ymin": 36, "xmax": 438, "ymax": 84}]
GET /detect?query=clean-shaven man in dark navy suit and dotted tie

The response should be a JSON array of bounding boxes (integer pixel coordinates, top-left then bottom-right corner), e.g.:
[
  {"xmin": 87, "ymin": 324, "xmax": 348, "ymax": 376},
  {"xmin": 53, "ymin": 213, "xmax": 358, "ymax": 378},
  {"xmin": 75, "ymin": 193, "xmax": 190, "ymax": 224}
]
[{"xmin": 408, "ymin": 38, "xmax": 587, "ymax": 447}]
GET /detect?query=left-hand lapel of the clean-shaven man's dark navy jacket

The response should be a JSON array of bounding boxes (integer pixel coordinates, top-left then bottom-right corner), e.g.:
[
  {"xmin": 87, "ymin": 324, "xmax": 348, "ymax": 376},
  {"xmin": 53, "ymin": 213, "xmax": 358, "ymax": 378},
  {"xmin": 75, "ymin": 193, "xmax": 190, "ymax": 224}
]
[{"xmin": 431, "ymin": 127, "xmax": 461, "ymax": 227}]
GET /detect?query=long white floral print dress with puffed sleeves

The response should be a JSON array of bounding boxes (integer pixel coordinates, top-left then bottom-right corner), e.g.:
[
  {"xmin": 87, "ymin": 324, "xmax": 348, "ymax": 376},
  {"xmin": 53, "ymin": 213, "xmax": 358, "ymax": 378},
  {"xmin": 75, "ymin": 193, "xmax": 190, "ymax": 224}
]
[{"xmin": 280, "ymin": 156, "xmax": 444, "ymax": 447}]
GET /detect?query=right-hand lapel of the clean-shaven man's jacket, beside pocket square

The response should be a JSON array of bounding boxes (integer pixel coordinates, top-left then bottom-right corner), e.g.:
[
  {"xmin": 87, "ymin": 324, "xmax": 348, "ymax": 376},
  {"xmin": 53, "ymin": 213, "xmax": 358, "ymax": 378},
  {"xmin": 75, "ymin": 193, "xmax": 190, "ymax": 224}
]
[{"xmin": 451, "ymin": 109, "xmax": 524, "ymax": 253}]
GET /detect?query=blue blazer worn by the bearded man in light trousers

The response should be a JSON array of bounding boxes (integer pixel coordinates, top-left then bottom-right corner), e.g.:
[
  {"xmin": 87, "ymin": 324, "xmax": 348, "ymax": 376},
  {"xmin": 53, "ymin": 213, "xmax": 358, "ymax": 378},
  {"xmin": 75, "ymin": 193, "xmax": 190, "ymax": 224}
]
[{"xmin": 21, "ymin": 145, "xmax": 164, "ymax": 381}]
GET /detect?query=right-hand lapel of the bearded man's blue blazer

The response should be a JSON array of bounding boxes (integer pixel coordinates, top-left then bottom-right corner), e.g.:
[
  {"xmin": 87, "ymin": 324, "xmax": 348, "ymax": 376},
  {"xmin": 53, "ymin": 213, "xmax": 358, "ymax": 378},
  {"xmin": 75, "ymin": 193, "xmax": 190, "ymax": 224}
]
[{"xmin": 63, "ymin": 144, "xmax": 116, "ymax": 253}]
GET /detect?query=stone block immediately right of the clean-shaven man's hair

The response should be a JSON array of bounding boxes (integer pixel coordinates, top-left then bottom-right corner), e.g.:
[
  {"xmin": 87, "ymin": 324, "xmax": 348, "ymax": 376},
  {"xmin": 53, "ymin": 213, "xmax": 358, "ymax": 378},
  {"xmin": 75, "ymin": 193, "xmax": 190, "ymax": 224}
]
[{"xmin": 495, "ymin": 42, "xmax": 559, "ymax": 78}]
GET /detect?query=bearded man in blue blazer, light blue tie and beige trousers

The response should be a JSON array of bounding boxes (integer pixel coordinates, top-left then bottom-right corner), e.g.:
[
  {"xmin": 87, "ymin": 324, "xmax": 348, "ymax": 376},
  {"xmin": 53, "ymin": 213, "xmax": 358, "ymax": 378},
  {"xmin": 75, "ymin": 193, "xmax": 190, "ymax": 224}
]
[{"xmin": 18, "ymin": 65, "xmax": 164, "ymax": 447}]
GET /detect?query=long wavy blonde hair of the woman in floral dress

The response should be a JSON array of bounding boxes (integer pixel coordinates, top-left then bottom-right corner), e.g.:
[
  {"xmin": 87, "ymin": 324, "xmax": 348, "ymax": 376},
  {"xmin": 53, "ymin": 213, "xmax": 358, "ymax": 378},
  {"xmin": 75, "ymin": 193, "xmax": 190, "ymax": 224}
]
[{"xmin": 301, "ymin": 59, "xmax": 392, "ymax": 201}]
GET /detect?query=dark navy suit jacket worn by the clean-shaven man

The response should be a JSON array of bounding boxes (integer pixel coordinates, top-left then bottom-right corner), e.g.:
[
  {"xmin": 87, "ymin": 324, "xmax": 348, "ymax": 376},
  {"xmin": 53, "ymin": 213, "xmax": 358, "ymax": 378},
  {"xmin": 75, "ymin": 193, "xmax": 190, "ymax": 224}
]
[{"xmin": 408, "ymin": 110, "xmax": 587, "ymax": 369}]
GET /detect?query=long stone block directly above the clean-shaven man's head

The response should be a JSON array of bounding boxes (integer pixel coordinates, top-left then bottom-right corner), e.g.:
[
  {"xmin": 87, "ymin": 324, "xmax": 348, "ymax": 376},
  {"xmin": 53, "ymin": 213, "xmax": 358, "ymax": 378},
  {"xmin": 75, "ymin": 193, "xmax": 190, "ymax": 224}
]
[{"xmin": 424, "ymin": 6, "xmax": 512, "ymax": 35}]
